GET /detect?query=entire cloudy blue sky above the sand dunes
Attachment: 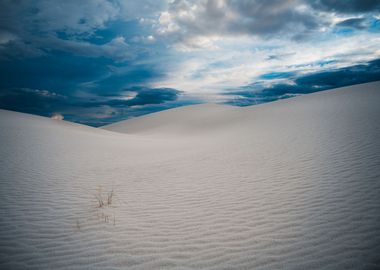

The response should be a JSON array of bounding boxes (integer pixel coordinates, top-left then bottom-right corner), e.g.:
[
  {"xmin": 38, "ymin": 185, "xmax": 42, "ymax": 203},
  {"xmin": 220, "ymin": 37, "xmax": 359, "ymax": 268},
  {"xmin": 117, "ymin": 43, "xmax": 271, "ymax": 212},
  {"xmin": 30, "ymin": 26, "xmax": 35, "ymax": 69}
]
[{"xmin": 0, "ymin": 0, "xmax": 380, "ymax": 126}]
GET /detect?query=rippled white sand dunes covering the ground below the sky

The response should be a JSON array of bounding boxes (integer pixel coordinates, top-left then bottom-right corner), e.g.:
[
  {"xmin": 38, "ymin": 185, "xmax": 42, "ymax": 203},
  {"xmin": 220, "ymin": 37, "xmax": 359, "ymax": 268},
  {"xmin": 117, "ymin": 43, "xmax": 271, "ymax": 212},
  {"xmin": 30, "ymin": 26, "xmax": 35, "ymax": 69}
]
[{"xmin": 0, "ymin": 82, "xmax": 380, "ymax": 270}]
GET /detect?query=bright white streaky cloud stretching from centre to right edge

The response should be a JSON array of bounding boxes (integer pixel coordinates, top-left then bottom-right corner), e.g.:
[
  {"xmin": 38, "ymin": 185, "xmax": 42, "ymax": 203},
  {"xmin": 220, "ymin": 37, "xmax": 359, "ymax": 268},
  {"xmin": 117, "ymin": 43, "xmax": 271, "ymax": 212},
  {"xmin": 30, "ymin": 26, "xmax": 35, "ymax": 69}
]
[{"xmin": 154, "ymin": 33, "xmax": 380, "ymax": 94}]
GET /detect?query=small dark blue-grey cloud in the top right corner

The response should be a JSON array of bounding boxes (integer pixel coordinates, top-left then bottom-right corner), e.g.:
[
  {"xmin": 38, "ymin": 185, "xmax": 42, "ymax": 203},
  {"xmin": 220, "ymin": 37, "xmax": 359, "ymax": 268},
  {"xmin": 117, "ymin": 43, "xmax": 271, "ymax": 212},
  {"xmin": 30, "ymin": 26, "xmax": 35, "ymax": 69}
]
[{"xmin": 309, "ymin": 0, "xmax": 380, "ymax": 13}]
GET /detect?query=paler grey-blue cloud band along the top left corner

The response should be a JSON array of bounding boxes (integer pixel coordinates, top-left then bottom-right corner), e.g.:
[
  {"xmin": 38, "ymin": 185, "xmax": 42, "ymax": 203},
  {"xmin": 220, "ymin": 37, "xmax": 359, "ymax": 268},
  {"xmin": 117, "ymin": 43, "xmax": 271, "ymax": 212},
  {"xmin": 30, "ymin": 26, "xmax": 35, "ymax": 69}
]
[{"xmin": 0, "ymin": 0, "xmax": 166, "ymax": 36}]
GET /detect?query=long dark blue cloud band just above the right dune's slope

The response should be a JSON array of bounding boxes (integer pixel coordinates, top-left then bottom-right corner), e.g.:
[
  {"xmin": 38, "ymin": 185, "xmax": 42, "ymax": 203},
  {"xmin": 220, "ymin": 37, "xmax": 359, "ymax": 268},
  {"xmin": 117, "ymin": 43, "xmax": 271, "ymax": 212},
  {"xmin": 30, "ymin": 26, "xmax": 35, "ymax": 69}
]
[{"xmin": 226, "ymin": 59, "xmax": 380, "ymax": 106}]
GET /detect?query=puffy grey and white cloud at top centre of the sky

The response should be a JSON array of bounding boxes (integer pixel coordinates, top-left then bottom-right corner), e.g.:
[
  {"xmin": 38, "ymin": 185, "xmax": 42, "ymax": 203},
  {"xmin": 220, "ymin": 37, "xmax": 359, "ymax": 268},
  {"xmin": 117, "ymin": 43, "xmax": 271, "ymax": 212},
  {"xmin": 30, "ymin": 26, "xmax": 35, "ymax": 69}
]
[{"xmin": 158, "ymin": 0, "xmax": 324, "ymax": 47}]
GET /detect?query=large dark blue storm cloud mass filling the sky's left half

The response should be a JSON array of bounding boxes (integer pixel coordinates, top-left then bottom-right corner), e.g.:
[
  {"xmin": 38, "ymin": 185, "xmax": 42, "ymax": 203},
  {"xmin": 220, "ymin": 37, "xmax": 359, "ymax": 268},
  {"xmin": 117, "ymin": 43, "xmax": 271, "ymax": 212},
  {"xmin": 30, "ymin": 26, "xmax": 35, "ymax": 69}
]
[{"xmin": 0, "ymin": 0, "xmax": 180, "ymax": 125}]
